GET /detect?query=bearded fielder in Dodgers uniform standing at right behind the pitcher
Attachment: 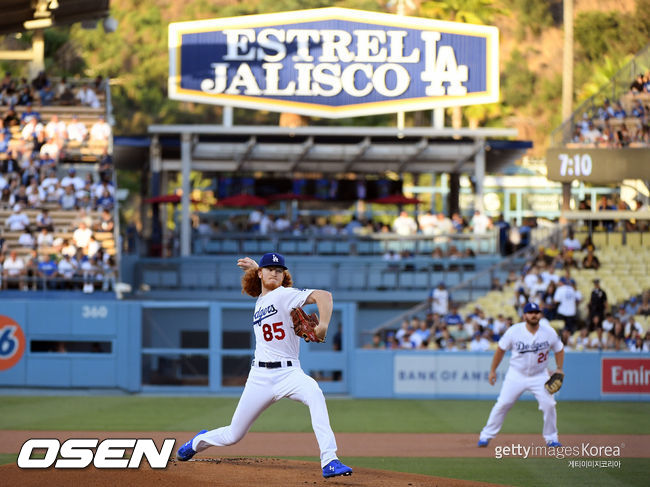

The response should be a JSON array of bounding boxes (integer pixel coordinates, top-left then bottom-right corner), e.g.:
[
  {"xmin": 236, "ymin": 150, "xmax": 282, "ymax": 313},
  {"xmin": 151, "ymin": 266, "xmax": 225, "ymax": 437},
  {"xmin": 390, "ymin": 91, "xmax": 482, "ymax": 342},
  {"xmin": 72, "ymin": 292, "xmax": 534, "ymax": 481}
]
[{"xmin": 478, "ymin": 303, "xmax": 564, "ymax": 447}]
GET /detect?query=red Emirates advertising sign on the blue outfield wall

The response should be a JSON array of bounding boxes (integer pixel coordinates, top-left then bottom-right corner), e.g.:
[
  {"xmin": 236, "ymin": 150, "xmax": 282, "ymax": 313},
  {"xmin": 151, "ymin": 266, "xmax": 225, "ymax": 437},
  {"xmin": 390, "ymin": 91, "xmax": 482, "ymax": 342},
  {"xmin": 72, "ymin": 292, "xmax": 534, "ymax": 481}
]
[{"xmin": 601, "ymin": 358, "xmax": 650, "ymax": 394}]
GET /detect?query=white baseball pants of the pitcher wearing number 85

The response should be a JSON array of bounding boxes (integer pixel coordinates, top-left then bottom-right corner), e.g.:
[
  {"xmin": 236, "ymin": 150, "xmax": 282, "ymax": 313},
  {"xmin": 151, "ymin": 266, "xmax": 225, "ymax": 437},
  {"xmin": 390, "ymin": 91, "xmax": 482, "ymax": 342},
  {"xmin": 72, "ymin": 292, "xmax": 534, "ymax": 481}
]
[{"xmin": 192, "ymin": 360, "xmax": 337, "ymax": 467}]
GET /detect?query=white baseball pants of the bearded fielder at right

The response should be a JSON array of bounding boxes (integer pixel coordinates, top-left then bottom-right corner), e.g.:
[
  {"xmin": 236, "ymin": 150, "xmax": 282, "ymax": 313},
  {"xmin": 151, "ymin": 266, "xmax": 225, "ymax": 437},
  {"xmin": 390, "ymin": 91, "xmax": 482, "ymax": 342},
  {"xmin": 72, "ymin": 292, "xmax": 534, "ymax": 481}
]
[{"xmin": 479, "ymin": 369, "xmax": 558, "ymax": 443}]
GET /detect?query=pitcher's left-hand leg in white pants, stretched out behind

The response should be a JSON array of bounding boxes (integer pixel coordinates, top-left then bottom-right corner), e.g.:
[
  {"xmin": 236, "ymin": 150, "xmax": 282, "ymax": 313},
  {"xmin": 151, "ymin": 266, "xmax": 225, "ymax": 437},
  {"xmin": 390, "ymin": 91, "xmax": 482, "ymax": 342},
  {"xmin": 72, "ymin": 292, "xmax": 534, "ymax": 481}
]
[{"xmin": 192, "ymin": 373, "xmax": 274, "ymax": 452}]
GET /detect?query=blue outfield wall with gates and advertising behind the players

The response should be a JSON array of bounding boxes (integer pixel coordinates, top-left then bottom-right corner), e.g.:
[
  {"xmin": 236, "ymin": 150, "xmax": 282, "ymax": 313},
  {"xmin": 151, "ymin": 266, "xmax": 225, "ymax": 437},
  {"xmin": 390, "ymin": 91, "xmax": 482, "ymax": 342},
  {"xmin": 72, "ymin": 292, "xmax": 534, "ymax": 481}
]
[{"xmin": 0, "ymin": 299, "xmax": 650, "ymax": 401}]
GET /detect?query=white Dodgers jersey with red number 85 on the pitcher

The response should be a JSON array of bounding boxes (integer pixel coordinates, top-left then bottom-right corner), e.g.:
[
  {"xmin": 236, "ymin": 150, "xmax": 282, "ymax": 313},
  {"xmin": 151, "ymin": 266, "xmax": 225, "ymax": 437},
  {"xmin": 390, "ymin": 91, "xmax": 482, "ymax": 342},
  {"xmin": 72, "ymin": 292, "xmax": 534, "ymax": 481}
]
[{"xmin": 253, "ymin": 286, "xmax": 314, "ymax": 362}]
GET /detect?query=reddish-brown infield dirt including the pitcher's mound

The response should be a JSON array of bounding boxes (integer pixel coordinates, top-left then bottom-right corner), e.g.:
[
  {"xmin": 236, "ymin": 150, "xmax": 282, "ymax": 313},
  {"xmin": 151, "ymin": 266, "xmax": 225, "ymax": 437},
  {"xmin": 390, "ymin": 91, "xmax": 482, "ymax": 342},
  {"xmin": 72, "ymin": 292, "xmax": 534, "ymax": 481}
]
[{"xmin": 0, "ymin": 430, "xmax": 650, "ymax": 487}]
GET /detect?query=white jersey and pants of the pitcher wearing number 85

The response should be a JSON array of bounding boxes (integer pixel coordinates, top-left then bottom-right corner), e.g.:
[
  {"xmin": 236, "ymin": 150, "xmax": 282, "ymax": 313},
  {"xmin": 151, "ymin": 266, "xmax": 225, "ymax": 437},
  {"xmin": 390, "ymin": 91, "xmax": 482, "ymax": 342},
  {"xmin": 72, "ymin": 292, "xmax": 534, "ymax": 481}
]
[{"xmin": 192, "ymin": 286, "xmax": 337, "ymax": 467}]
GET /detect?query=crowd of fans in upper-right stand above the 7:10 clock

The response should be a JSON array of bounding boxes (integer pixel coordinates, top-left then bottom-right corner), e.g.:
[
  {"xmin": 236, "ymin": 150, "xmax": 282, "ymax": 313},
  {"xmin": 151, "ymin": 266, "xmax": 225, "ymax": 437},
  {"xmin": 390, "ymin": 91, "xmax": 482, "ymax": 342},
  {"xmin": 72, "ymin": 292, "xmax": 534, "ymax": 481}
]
[{"xmin": 572, "ymin": 69, "xmax": 650, "ymax": 148}]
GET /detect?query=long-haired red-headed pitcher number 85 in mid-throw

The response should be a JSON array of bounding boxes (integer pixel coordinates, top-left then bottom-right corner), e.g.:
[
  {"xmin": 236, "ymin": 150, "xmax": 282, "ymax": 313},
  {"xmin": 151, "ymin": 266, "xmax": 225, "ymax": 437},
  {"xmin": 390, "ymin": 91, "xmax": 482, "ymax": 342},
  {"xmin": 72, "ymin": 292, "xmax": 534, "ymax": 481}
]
[{"xmin": 176, "ymin": 253, "xmax": 352, "ymax": 478}]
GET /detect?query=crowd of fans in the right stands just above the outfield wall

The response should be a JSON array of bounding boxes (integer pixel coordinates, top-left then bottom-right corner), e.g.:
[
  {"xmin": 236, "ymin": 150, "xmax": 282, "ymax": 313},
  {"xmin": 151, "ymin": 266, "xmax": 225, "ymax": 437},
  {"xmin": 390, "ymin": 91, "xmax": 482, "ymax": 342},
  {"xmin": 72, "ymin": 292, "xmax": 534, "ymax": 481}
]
[{"xmin": 368, "ymin": 233, "xmax": 650, "ymax": 352}]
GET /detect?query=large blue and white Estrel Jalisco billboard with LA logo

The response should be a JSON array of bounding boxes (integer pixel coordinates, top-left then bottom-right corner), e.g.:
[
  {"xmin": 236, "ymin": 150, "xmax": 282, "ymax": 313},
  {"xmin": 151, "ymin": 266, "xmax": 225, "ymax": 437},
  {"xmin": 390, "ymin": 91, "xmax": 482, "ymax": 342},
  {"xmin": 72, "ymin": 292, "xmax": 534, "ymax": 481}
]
[{"xmin": 169, "ymin": 8, "xmax": 499, "ymax": 118}]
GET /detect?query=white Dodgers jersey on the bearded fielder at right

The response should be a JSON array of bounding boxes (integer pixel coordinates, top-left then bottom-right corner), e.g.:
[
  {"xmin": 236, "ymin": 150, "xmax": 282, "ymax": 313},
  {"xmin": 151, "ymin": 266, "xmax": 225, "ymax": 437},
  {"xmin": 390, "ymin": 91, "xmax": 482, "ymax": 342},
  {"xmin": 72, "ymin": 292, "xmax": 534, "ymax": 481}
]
[{"xmin": 499, "ymin": 321, "xmax": 564, "ymax": 375}]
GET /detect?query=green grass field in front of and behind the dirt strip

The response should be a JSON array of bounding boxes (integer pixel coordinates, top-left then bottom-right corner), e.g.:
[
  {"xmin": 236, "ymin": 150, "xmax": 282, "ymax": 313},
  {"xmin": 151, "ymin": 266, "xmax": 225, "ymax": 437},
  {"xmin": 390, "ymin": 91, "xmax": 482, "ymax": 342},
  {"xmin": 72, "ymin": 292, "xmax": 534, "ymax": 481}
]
[{"xmin": 0, "ymin": 396, "xmax": 650, "ymax": 487}]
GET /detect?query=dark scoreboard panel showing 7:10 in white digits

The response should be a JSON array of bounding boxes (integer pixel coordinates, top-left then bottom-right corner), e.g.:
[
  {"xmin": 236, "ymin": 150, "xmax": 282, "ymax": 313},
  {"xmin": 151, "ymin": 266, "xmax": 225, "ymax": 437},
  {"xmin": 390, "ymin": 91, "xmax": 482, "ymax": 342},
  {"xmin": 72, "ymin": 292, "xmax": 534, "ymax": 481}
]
[{"xmin": 546, "ymin": 148, "xmax": 650, "ymax": 183}]
